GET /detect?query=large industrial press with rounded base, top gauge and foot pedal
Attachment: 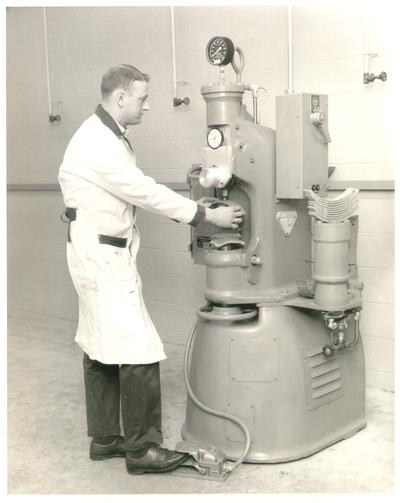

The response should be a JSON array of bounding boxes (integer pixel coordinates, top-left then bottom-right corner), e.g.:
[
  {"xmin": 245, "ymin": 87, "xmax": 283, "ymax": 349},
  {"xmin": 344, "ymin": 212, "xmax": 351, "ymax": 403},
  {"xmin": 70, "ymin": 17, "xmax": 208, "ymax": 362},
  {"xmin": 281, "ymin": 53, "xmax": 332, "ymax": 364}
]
[{"xmin": 176, "ymin": 36, "xmax": 366, "ymax": 479}]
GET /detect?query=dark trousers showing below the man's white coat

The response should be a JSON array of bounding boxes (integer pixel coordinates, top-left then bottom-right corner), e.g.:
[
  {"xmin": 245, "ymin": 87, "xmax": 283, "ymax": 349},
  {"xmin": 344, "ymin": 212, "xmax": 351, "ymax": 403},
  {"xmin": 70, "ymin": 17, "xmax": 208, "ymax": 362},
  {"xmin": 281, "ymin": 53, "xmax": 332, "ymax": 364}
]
[{"xmin": 83, "ymin": 353, "xmax": 163, "ymax": 450}]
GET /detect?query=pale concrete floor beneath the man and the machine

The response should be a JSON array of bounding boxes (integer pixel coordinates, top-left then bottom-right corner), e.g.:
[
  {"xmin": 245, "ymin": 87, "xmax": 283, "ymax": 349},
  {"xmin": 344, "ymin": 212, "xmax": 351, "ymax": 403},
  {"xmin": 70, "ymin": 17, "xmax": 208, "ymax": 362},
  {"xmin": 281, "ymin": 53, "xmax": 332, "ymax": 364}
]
[{"xmin": 8, "ymin": 311, "xmax": 394, "ymax": 496}]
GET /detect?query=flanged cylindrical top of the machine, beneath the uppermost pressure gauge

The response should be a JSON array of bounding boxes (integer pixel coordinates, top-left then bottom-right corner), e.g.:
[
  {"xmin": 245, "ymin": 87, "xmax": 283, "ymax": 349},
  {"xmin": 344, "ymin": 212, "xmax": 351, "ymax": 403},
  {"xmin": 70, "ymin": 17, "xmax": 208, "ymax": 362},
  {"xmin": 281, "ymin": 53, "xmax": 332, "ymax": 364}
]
[{"xmin": 201, "ymin": 84, "xmax": 244, "ymax": 126}]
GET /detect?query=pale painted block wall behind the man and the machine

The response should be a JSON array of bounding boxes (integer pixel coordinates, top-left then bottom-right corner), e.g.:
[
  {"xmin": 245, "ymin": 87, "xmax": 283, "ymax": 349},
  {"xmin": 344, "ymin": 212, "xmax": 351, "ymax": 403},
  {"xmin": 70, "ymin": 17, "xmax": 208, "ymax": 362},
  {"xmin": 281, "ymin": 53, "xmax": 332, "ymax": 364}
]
[{"xmin": 7, "ymin": 6, "xmax": 394, "ymax": 389}]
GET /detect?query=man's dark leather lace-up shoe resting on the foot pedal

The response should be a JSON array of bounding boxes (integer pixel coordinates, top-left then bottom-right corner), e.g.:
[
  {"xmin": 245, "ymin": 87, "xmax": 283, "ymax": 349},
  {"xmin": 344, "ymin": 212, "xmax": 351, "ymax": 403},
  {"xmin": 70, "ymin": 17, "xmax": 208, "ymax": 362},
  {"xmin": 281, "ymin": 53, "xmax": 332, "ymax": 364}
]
[{"xmin": 126, "ymin": 445, "xmax": 189, "ymax": 475}]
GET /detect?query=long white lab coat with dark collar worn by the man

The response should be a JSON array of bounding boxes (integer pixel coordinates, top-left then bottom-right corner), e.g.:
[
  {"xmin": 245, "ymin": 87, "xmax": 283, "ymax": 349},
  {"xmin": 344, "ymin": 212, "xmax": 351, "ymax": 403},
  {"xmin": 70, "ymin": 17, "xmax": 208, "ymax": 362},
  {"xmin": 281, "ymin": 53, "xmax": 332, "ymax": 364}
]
[{"xmin": 59, "ymin": 115, "xmax": 197, "ymax": 364}]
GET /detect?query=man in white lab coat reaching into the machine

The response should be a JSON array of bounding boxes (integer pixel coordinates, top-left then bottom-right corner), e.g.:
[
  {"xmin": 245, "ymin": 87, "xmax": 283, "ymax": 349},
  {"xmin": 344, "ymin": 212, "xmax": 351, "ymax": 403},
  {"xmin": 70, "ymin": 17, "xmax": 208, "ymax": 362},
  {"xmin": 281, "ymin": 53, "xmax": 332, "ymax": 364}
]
[{"xmin": 59, "ymin": 65, "xmax": 244, "ymax": 474}]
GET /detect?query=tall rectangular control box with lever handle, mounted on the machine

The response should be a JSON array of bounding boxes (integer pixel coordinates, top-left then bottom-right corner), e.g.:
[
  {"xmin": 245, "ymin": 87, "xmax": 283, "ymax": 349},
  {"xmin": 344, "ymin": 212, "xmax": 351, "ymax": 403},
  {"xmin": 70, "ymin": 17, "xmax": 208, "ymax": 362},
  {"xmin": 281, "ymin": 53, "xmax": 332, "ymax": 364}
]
[{"xmin": 276, "ymin": 93, "xmax": 330, "ymax": 199}]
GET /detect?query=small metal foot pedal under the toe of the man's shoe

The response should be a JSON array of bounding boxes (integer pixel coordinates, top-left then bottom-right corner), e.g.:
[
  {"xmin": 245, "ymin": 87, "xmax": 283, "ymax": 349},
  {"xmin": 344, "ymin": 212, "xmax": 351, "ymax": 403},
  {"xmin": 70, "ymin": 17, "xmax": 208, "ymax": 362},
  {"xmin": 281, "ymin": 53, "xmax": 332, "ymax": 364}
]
[{"xmin": 174, "ymin": 440, "xmax": 234, "ymax": 482}]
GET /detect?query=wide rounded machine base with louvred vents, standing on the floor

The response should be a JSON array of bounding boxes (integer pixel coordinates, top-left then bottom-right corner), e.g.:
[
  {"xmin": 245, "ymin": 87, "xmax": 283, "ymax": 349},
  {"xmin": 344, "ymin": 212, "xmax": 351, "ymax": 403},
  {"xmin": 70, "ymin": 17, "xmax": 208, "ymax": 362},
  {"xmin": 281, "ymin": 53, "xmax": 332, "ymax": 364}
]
[{"xmin": 182, "ymin": 305, "xmax": 366, "ymax": 463}]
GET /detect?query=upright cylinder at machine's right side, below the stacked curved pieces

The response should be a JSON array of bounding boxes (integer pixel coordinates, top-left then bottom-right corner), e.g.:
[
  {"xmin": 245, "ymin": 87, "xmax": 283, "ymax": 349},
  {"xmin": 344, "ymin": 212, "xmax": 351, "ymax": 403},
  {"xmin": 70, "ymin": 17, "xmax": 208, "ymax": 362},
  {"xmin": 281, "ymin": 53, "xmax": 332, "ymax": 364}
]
[{"xmin": 313, "ymin": 220, "xmax": 351, "ymax": 307}]
